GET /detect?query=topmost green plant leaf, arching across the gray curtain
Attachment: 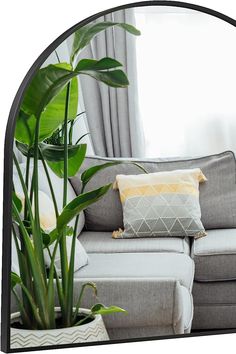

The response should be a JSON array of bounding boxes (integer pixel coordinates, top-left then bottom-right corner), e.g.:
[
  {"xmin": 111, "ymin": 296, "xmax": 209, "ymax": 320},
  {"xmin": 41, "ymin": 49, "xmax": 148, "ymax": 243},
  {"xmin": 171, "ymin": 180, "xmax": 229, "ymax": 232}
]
[{"xmin": 71, "ymin": 21, "xmax": 141, "ymax": 62}]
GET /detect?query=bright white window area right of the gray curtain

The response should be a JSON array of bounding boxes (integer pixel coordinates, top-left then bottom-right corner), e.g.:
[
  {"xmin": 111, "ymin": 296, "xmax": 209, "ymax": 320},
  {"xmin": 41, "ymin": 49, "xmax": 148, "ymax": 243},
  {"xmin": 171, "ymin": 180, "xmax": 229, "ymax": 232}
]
[{"xmin": 135, "ymin": 8, "xmax": 236, "ymax": 157}]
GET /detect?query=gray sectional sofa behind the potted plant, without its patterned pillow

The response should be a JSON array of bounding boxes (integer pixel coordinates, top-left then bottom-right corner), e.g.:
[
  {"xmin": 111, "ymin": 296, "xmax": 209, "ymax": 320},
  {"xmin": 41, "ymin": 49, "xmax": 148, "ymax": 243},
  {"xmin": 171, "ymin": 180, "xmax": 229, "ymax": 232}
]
[{"xmin": 71, "ymin": 151, "xmax": 236, "ymax": 339}]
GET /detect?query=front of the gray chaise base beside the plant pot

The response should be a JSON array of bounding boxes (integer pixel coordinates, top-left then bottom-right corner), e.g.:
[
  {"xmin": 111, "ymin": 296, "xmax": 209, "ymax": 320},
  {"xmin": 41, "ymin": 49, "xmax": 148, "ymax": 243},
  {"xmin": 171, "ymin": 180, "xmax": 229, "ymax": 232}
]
[{"xmin": 74, "ymin": 277, "xmax": 193, "ymax": 333}]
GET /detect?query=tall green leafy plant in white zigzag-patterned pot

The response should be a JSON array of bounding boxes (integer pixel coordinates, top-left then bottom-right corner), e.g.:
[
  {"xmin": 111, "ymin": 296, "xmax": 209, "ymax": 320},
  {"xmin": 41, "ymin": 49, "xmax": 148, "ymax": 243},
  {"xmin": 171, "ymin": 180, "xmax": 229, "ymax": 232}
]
[{"xmin": 11, "ymin": 22, "xmax": 139, "ymax": 348}]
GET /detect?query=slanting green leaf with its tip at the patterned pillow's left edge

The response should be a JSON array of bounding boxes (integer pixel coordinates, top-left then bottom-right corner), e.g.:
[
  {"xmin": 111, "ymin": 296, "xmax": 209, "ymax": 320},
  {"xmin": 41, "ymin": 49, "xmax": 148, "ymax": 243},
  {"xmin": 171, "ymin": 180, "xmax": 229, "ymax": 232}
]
[{"xmin": 57, "ymin": 184, "xmax": 111, "ymax": 231}]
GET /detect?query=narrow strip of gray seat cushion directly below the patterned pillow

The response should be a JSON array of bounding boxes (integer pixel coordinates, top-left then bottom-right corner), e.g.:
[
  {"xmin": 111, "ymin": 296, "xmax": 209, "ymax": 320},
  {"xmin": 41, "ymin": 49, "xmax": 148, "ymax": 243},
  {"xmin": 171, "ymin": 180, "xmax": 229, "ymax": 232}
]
[{"xmin": 79, "ymin": 231, "xmax": 190, "ymax": 257}]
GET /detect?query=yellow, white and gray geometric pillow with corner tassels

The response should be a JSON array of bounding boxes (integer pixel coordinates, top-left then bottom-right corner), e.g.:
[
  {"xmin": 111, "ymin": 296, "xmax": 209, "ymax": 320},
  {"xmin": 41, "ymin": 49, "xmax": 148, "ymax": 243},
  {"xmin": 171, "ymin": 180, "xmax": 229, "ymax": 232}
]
[{"xmin": 113, "ymin": 168, "xmax": 207, "ymax": 238}]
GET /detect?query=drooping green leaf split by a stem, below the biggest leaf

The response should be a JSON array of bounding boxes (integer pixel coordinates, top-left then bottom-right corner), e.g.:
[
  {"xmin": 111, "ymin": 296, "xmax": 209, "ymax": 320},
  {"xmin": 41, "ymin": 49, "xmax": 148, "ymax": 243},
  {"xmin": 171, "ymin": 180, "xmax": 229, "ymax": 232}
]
[{"xmin": 45, "ymin": 144, "xmax": 87, "ymax": 178}]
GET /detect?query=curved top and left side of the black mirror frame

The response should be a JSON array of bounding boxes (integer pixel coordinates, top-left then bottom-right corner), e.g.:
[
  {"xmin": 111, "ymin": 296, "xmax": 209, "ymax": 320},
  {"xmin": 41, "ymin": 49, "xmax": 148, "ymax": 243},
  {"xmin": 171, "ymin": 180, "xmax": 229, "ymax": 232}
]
[{"xmin": 2, "ymin": 1, "xmax": 236, "ymax": 351}]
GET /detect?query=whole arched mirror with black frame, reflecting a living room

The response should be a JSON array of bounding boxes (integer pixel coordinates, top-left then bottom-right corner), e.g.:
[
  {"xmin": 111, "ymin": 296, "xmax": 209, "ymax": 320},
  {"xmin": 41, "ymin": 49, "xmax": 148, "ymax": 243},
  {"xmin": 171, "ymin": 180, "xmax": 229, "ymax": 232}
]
[{"xmin": 2, "ymin": 1, "xmax": 236, "ymax": 352}]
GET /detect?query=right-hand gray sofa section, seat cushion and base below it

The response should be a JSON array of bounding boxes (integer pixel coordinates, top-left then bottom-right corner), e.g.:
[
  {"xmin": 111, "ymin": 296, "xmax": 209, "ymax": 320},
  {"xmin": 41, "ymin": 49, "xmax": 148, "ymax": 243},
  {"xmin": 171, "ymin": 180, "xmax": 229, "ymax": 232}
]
[{"xmin": 191, "ymin": 229, "xmax": 236, "ymax": 329}]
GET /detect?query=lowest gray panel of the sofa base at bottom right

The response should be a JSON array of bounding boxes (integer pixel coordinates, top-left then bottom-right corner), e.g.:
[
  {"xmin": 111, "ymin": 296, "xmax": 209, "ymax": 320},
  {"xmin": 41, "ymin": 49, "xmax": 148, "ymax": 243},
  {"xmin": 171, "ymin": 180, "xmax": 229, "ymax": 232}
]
[{"xmin": 192, "ymin": 304, "xmax": 236, "ymax": 330}]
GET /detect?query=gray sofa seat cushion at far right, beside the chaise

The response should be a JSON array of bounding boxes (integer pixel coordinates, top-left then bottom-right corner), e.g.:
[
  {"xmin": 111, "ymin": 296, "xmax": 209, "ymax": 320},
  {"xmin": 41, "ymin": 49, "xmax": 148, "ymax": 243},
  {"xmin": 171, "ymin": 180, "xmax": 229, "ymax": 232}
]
[{"xmin": 191, "ymin": 229, "xmax": 236, "ymax": 282}]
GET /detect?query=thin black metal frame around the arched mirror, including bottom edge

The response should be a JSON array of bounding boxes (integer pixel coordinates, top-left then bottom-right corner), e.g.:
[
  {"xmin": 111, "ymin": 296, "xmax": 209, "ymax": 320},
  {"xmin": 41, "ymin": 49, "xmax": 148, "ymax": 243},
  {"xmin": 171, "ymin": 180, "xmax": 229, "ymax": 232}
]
[{"xmin": 1, "ymin": 1, "xmax": 236, "ymax": 352}]
